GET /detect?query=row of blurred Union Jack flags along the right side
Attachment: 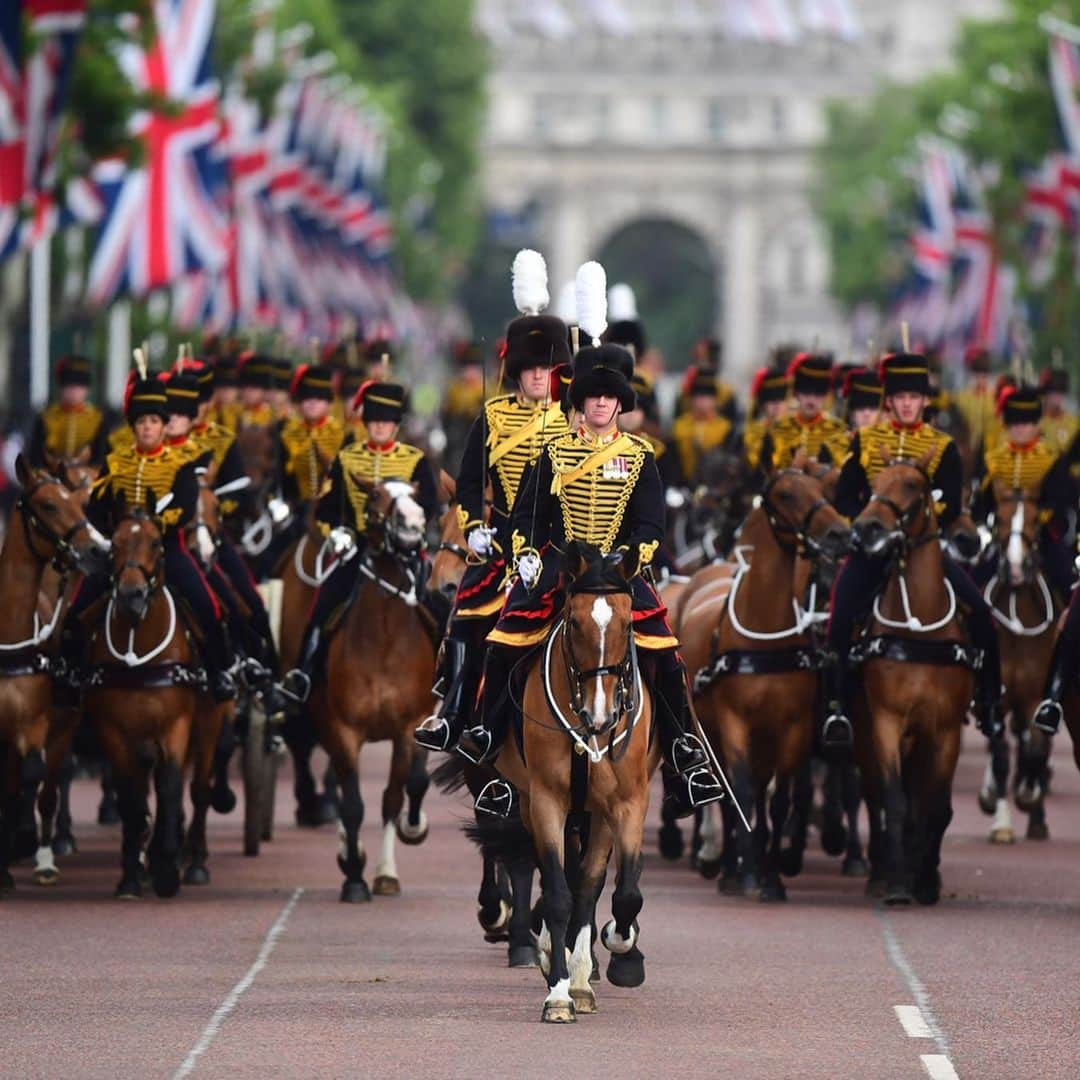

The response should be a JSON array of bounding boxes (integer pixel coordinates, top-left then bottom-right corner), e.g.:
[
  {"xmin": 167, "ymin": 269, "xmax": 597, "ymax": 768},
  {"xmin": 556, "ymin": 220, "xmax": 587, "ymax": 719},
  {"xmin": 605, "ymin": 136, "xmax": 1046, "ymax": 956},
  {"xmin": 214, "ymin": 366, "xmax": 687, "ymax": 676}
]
[{"xmin": 892, "ymin": 17, "xmax": 1080, "ymax": 361}]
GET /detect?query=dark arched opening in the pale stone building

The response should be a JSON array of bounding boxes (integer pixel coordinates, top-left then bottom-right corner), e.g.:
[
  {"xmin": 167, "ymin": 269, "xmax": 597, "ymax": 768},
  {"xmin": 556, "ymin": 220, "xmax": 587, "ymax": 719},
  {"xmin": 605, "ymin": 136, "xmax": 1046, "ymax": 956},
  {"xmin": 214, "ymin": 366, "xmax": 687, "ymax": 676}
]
[{"xmin": 594, "ymin": 215, "xmax": 723, "ymax": 370}]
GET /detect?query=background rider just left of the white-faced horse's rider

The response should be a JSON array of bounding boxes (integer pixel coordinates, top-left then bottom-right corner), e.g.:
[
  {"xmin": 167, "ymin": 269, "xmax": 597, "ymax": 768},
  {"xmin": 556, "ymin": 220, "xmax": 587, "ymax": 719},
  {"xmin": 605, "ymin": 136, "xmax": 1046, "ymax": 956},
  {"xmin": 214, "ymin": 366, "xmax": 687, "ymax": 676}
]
[{"xmin": 260, "ymin": 364, "xmax": 345, "ymax": 575}]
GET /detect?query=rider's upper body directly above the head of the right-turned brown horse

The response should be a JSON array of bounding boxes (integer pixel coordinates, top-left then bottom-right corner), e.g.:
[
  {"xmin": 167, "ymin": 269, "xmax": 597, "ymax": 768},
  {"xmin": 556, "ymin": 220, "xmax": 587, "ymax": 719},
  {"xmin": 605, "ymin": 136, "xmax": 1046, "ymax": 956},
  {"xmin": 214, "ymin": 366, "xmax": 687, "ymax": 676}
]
[{"xmin": 760, "ymin": 352, "xmax": 850, "ymax": 474}]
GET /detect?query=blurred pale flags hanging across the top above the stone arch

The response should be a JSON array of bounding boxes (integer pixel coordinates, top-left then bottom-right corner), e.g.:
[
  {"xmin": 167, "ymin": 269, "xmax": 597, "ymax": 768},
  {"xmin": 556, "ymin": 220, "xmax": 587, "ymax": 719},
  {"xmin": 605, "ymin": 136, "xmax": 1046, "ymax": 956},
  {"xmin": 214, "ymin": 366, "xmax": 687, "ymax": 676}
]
[{"xmin": 476, "ymin": 0, "xmax": 861, "ymax": 45}]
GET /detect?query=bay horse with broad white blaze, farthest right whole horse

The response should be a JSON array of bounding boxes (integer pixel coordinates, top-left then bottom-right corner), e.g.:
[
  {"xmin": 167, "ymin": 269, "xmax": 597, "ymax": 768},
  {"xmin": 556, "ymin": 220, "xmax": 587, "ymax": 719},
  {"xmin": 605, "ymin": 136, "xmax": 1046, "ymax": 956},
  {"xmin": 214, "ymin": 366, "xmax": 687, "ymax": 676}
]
[{"xmin": 978, "ymin": 485, "xmax": 1057, "ymax": 843}]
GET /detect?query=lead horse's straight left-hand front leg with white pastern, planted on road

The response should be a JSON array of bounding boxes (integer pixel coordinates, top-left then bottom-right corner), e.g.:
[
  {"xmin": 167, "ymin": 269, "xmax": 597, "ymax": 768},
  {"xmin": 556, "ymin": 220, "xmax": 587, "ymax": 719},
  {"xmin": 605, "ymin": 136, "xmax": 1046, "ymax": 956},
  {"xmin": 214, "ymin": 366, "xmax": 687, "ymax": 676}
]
[{"xmin": 529, "ymin": 781, "xmax": 576, "ymax": 1024}]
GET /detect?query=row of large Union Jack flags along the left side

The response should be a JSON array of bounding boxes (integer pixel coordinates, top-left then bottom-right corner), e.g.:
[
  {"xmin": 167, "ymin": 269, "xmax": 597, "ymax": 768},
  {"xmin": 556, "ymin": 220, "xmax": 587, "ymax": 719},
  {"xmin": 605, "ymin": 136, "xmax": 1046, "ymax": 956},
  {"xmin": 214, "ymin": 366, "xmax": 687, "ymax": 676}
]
[{"xmin": 0, "ymin": 0, "xmax": 419, "ymax": 340}]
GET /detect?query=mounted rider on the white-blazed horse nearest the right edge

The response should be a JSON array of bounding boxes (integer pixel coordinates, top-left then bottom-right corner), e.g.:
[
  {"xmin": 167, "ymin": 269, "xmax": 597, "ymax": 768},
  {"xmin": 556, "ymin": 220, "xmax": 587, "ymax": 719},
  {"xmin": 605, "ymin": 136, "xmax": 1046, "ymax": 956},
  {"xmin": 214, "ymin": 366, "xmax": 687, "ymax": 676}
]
[{"xmin": 971, "ymin": 387, "xmax": 1077, "ymax": 603}]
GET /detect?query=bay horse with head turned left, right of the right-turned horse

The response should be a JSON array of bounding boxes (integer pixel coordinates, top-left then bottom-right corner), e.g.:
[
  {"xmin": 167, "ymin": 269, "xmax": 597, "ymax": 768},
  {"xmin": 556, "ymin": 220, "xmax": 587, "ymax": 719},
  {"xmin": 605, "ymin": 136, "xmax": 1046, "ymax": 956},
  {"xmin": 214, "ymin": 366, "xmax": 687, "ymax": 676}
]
[{"xmin": 852, "ymin": 451, "xmax": 973, "ymax": 905}]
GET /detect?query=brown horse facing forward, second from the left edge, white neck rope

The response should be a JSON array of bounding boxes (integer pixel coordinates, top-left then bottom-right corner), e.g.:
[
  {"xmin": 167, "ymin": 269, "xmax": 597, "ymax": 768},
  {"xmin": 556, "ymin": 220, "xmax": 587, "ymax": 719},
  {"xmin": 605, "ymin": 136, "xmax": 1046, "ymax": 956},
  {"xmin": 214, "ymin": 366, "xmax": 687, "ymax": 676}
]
[{"xmin": 84, "ymin": 495, "xmax": 232, "ymax": 900}]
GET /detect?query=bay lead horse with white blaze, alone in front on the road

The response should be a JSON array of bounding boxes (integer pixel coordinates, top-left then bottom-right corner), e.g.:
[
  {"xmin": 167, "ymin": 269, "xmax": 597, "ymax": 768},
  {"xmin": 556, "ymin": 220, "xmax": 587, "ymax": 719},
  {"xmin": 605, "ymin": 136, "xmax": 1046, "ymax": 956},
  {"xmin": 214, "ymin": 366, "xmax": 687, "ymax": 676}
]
[{"xmin": 495, "ymin": 541, "xmax": 660, "ymax": 1024}]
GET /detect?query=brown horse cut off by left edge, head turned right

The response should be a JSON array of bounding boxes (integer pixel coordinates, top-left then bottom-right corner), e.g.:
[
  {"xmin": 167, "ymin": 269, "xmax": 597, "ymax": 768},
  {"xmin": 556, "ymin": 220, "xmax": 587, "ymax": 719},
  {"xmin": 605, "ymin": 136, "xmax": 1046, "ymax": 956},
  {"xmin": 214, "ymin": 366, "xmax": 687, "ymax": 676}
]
[{"xmin": 0, "ymin": 455, "xmax": 108, "ymax": 889}]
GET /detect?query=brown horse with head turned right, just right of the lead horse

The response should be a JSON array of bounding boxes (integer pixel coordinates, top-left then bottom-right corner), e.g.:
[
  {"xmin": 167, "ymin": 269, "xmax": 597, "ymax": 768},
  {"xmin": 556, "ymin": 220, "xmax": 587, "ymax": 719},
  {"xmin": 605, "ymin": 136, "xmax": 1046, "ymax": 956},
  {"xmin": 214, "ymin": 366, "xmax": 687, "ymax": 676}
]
[{"xmin": 676, "ymin": 463, "xmax": 850, "ymax": 901}]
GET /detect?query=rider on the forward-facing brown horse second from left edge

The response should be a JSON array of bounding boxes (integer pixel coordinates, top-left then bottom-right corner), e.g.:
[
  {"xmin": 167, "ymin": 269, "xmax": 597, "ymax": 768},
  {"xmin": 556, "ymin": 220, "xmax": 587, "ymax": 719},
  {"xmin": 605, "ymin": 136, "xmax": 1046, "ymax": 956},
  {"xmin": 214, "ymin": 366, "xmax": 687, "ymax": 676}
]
[{"xmin": 63, "ymin": 374, "xmax": 235, "ymax": 702}]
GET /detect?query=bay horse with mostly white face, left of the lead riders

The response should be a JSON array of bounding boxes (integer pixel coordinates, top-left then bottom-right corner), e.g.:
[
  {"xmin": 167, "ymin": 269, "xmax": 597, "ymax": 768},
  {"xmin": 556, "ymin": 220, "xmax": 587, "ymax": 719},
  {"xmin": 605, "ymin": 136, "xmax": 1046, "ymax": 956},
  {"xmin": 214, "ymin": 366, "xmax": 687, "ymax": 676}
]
[{"xmin": 309, "ymin": 478, "xmax": 436, "ymax": 903}]
